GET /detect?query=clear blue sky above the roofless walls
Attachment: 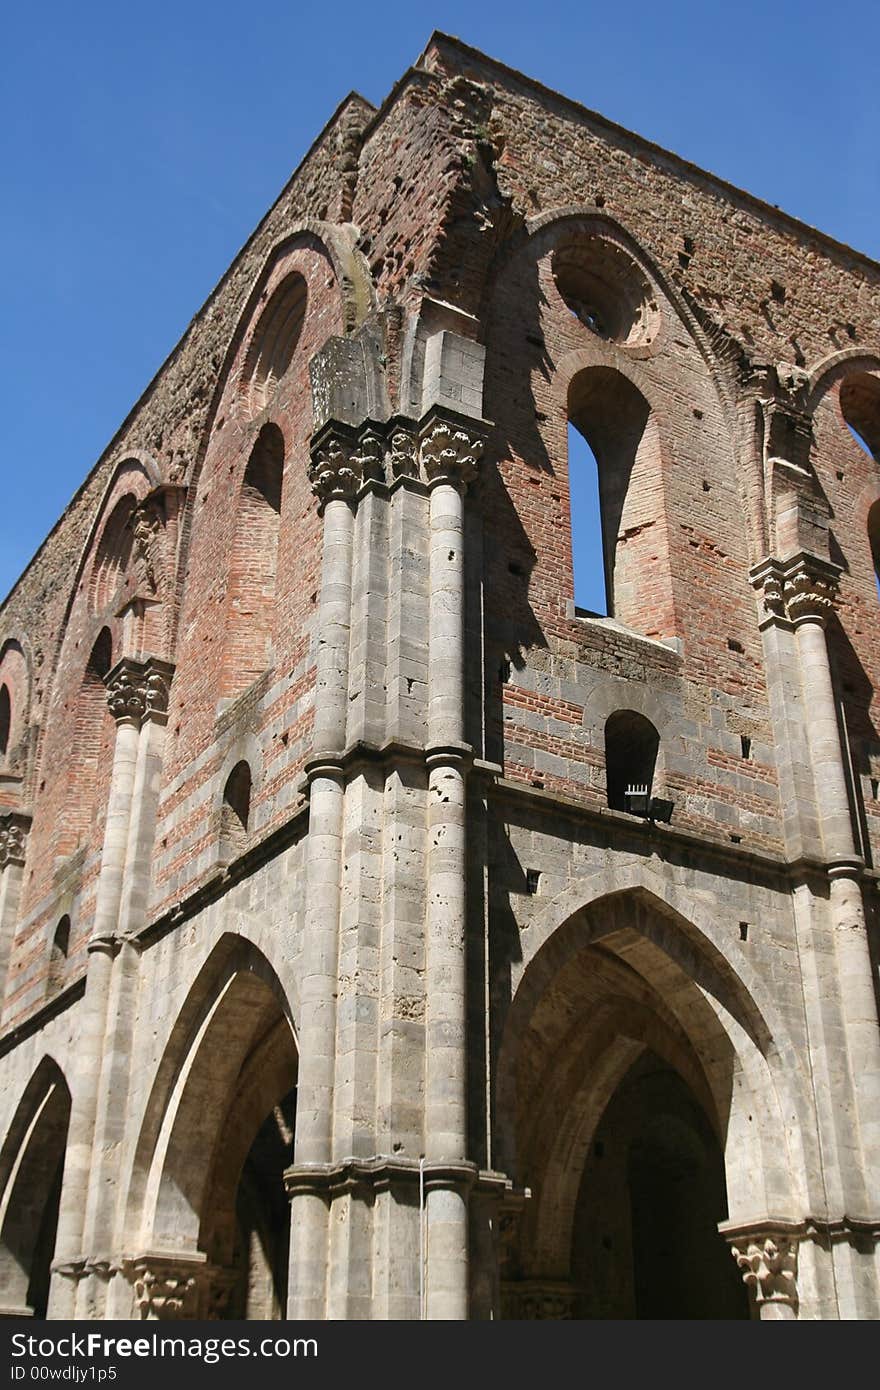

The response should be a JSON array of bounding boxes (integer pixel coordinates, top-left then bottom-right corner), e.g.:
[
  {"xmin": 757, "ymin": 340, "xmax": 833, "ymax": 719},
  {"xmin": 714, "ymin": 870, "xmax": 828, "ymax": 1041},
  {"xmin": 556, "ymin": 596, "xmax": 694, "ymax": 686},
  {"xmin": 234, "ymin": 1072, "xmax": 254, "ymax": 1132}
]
[{"xmin": 0, "ymin": 0, "xmax": 880, "ymax": 595}]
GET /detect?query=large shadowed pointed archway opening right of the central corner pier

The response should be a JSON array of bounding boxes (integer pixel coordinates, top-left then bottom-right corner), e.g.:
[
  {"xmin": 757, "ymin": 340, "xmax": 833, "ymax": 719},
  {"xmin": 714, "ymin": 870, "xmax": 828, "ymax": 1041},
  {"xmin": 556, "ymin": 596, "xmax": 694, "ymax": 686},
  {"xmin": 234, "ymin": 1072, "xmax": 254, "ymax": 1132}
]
[{"xmin": 495, "ymin": 892, "xmax": 766, "ymax": 1319}]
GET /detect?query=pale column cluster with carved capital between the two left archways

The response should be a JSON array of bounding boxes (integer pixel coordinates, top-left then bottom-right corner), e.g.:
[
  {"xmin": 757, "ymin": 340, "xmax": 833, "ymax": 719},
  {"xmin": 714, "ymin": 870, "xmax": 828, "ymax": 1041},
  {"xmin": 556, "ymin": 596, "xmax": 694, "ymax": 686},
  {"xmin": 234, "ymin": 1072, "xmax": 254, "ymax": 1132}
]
[{"xmin": 49, "ymin": 656, "xmax": 174, "ymax": 1318}]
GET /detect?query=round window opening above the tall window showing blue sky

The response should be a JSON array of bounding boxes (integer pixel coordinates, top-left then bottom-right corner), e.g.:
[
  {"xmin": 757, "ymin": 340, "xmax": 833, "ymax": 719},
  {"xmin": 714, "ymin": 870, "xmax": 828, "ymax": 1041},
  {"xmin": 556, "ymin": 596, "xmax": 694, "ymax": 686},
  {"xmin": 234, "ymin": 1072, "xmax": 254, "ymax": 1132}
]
[{"xmin": 552, "ymin": 238, "xmax": 659, "ymax": 343}]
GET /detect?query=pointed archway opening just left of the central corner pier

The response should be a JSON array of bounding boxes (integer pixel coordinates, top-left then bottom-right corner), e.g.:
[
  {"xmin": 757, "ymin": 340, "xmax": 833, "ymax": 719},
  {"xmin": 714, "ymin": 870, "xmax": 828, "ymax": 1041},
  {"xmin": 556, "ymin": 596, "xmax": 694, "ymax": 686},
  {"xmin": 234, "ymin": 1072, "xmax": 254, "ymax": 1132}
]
[{"xmin": 133, "ymin": 947, "xmax": 298, "ymax": 1319}]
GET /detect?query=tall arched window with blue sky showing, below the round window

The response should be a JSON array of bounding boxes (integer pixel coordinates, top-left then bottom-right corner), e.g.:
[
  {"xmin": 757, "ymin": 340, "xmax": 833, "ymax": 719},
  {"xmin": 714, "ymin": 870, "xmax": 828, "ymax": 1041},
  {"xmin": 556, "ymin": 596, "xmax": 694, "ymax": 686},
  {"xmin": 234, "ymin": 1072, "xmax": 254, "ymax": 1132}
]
[{"xmin": 569, "ymin": 367, "xmax": 658, "ymax": 635}]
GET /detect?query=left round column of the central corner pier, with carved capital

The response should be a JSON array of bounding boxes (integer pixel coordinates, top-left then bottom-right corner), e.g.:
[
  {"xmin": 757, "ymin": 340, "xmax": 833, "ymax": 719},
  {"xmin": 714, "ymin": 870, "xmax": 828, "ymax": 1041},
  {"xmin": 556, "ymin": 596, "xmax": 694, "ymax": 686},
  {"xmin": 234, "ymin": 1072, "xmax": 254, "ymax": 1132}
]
[{"xmin": 289, "ymin": 428, "xmax": 360, "ymax": 1319}]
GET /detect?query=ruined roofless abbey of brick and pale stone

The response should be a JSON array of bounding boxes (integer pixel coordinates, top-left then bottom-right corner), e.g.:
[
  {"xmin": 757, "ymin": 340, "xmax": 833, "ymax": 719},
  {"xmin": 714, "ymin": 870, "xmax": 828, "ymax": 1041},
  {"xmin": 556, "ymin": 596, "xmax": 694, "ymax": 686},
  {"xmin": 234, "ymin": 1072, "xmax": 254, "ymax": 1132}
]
[{"xmin": 0, "ymin": 35, "xmax": 880, "ymax": 1319}]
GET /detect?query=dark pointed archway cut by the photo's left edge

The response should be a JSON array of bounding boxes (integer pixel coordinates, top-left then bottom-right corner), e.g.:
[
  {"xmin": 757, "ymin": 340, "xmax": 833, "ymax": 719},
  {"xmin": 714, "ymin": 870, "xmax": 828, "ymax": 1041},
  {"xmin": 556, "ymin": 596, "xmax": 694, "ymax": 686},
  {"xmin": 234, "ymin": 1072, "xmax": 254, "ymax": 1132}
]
[{"xmin": 0, "ymin": 1061, "xmax": 71, "ymax": 1318}]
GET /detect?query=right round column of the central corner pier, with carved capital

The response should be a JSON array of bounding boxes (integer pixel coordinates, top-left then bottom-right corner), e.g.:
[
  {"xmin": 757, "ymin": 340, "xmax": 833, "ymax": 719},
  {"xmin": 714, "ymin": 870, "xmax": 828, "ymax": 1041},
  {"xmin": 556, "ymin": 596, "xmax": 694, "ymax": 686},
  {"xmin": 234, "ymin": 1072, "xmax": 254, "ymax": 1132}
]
[{"xmin": 421, "ymin": 420, "xmax": 482, "ymax": 1319}]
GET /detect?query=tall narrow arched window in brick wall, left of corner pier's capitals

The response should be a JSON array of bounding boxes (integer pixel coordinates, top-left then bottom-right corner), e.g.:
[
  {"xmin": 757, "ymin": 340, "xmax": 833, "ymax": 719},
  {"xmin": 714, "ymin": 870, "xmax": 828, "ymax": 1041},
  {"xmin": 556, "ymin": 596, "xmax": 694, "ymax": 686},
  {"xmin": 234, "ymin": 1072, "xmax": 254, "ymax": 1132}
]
[{"xmin": 224, "ymin": 424, "xmax": 284, "ymax": 696}]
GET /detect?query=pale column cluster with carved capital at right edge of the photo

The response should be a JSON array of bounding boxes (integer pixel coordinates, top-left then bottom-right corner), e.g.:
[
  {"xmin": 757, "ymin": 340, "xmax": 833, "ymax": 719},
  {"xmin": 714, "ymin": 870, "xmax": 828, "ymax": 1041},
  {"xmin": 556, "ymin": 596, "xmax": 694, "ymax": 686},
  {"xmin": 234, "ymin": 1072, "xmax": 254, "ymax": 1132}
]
[{"xmin": 745, "ymin": 550, "xmax": 880, "ymax": 1318}]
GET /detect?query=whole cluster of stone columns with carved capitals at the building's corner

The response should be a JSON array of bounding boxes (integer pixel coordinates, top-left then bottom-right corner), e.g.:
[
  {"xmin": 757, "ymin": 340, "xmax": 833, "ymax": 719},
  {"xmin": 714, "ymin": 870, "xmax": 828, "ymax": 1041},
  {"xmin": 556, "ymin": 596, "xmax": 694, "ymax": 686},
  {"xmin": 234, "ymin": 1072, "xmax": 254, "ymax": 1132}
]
[{"xmin": 286, "ymin": 413, "xmax": 491, "ymax": 1319}]
